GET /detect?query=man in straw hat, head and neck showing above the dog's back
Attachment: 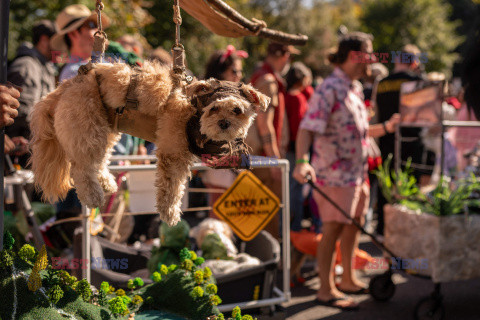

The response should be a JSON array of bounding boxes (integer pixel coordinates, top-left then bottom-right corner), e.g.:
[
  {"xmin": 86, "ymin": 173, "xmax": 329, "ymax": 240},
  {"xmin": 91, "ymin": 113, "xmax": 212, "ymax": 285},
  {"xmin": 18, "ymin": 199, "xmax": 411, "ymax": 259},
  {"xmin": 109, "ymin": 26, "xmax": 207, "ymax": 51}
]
[{"xmin": 50, "ymin": 4, "xmax": 110, "ymax": 82}]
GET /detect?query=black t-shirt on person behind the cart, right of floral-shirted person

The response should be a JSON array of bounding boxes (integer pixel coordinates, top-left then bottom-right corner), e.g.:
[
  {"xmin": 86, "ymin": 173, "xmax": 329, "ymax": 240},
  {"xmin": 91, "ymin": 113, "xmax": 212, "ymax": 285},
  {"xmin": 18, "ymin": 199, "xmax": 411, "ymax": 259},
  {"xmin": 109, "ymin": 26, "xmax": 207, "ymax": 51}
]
[{"xmin": 376, "ymin": 71, "xmax": 432, "ymax": 172}]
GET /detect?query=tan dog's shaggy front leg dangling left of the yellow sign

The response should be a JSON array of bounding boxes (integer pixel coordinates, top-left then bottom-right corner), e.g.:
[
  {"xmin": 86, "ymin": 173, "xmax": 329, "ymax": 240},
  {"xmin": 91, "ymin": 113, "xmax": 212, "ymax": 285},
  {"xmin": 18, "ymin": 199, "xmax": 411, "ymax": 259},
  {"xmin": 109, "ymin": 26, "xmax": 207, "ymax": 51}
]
[{"xmin": 156, "ymin": 151, "xmax": 193, "ymax": 226}]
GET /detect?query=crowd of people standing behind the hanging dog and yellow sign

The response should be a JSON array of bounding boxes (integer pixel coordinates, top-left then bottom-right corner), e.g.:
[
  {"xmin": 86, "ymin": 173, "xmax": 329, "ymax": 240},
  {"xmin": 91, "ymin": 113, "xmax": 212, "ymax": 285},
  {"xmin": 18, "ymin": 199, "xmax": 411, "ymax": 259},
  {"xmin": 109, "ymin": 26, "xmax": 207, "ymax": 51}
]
[{"xmin": 0, "ymin": 1, "xmax": 478, "ymax": 309}]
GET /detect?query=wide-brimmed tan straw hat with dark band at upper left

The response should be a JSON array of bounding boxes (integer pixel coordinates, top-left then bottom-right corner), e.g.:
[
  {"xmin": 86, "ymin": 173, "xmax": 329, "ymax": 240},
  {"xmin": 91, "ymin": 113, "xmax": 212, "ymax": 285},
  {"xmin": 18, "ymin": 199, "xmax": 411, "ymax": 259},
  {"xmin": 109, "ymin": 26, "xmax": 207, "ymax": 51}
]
[{"xmin": 50, "ymin": 4, "xmax": 110, "ymax": 52}]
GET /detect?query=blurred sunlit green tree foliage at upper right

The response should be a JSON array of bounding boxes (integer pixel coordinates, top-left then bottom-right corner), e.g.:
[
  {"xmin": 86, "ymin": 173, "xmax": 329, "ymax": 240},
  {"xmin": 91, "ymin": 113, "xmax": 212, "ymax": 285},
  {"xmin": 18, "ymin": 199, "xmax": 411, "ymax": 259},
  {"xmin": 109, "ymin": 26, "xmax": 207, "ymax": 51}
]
[{"xmin": 361, "ymin": 0, "xmax": 462, "ymax": 78}]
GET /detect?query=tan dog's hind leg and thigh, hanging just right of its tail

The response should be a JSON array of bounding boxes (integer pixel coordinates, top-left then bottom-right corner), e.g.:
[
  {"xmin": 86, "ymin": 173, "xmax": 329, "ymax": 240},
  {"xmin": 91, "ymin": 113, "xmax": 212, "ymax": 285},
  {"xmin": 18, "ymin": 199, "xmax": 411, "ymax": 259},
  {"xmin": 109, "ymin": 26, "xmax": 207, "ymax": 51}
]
[{"xmin": 55, "ymin": 74, "xmax": 112, "ymax": 208}]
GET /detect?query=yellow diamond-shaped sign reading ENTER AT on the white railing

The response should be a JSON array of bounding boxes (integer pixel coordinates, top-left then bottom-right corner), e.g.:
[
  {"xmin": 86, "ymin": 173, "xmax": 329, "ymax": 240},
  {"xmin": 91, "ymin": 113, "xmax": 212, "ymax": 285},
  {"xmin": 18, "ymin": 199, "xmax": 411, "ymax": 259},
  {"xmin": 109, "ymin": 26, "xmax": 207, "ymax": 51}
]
[{"xmin": 213, "ymin": 171, "xmax": 280, "ymax": 241}]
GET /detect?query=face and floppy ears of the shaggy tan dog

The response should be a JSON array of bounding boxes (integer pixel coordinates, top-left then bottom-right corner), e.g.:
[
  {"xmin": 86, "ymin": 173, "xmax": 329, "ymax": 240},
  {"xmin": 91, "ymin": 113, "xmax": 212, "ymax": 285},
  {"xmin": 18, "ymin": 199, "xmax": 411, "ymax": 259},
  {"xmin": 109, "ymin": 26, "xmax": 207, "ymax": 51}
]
[{"xmin": 186, "ymin": 79, "xmax": 270, "ymax": 141}]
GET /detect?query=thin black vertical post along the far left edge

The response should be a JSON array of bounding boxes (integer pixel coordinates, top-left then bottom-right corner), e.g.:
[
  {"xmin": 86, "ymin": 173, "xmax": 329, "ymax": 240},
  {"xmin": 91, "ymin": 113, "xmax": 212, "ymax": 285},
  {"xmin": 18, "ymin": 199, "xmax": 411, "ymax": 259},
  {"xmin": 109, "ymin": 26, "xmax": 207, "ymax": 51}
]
[{"xmin": 0, "ymin": 0, "xmax": 10, "ymax": 250}]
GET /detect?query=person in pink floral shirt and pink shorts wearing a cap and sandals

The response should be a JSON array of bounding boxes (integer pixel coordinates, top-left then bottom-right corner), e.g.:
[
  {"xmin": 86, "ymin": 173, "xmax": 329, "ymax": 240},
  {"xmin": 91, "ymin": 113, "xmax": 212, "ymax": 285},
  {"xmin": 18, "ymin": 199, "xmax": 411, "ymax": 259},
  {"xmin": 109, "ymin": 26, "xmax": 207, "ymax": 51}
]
[{"xmin": 293, "ymin": 32, "xmax": 399, "ymax": 310}]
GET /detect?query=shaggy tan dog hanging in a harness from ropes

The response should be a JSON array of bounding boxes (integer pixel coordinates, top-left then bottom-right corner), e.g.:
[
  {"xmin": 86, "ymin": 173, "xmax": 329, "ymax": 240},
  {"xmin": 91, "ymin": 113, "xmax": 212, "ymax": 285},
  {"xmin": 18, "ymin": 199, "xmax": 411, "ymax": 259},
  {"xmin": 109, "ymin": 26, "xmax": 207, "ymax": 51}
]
[{"xmin": 30, "ymin": 62, "xmax": 269, "ymax": 225}]
